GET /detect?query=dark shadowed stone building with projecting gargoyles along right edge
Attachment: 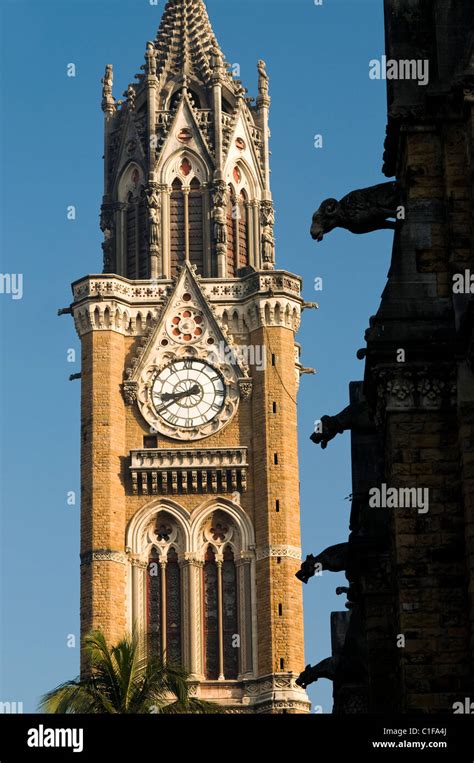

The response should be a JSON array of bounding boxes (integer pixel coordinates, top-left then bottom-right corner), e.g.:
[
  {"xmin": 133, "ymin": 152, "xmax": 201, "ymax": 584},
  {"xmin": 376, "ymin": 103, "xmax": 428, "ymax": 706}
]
[{"xmin": 302, "ymin": 0, "xmax": 474, "ymax": 713}]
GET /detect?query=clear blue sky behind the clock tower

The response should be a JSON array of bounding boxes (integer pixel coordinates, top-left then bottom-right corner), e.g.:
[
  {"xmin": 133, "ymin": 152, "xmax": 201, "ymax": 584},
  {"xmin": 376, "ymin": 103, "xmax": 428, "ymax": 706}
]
[{"xmin": 0, "ymin": 0, "xmax": 392, "ymax": 712}]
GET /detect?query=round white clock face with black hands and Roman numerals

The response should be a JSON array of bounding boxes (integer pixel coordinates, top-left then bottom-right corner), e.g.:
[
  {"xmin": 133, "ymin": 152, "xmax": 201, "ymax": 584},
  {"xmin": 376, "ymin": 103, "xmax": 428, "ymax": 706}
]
[{"xmin": 151, "ymin": 358, "xmax": 225, "ymax": 429}]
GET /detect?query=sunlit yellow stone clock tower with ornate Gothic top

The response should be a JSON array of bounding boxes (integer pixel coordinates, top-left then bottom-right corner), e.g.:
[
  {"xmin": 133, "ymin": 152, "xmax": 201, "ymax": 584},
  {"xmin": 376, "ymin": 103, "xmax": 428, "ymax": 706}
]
[{"xmin": 71, "ymin": 0, "xmax": 309, "ymax": 713}]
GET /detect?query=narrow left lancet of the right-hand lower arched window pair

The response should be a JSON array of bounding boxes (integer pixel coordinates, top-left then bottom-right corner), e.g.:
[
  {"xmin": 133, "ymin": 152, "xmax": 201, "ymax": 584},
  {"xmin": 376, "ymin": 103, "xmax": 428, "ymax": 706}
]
[{"xmin": 203, "ymin": 546, "xmax": 219, "ymax": 681}]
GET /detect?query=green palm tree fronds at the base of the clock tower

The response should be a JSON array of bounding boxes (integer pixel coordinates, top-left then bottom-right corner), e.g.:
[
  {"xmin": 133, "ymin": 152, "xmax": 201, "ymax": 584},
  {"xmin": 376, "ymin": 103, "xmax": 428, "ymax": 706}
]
[{"xmin": 39, "ymin": 631, "xmax": 221, "ymax": 714}]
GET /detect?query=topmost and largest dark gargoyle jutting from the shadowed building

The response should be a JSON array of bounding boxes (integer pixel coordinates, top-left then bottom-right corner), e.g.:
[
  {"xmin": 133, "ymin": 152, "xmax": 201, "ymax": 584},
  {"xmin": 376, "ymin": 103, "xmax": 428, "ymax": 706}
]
[{"xmin": 311, "ymin": 183, "xmax": 401, "ymax": 241}]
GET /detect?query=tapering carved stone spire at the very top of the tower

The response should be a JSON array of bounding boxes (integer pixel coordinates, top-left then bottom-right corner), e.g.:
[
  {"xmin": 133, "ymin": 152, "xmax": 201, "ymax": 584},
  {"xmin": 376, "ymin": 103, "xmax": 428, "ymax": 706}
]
[{"xmin": 151, "ymin": 0, "xmax": 235, "ymax": 90}]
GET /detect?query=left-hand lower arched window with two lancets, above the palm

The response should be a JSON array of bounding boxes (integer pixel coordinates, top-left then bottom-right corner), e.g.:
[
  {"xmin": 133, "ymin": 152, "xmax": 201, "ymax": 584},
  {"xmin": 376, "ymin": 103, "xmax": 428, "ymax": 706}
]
[{"xmin": 147, "ymin": 548, "xmax": 182, "ymax": 664}]
